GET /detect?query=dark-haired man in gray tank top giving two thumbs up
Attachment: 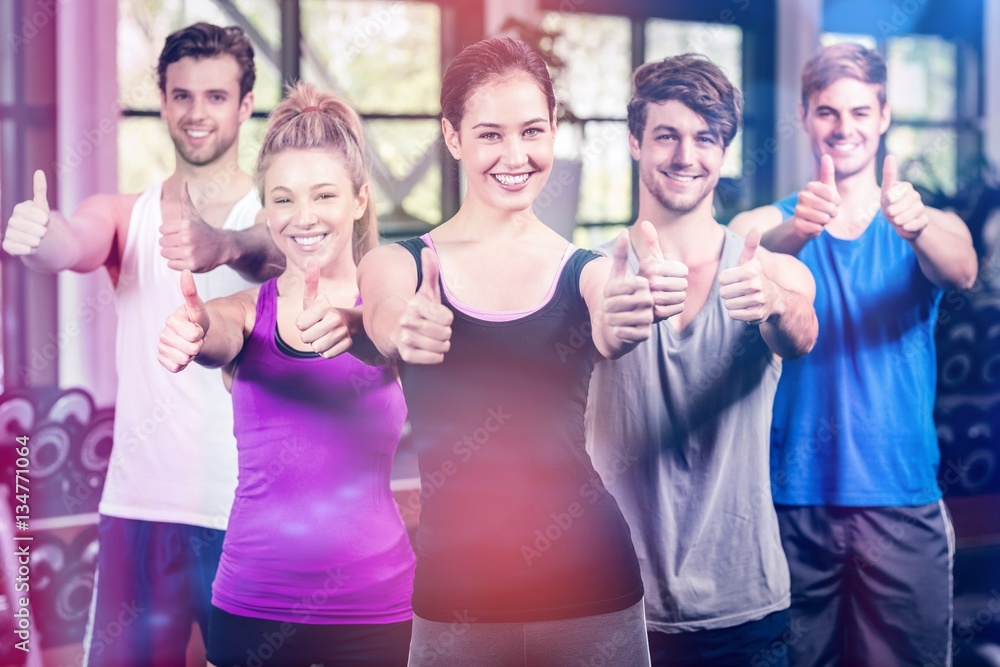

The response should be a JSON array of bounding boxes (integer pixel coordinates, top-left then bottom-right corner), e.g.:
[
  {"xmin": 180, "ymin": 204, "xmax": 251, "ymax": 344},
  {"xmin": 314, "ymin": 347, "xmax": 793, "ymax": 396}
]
[{"xmin": 587, "ymin": 55, "xmax": 817, "ymax": 665}]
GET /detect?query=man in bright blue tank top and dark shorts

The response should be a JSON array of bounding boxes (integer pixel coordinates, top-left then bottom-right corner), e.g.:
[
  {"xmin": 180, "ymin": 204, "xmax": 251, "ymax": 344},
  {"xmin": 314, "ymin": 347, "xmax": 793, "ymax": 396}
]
[{"xmin": 730, "ymin": 44, "xmax": 977, "ymax": 665}]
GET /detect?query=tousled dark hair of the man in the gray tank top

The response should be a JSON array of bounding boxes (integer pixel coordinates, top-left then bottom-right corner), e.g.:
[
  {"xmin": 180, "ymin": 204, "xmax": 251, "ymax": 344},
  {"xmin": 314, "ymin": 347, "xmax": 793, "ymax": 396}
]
[{"xmin": 628, "ymin": 53, "xmax": 743, "ymax": 148}]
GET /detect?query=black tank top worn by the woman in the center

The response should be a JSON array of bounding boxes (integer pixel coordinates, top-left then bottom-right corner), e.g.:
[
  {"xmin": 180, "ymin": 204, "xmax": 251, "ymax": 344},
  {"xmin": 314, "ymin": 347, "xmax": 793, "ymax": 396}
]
[{"xmin": 400, "ymin": 239, "xmax": 642, "ymax": 623}]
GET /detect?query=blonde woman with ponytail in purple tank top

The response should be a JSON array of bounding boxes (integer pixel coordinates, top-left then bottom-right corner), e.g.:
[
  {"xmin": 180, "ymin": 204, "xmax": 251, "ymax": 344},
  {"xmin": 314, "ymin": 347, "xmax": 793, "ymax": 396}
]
[{"xmin": 158, "ymin": 84, "xmax": 414, "ymax": 667}]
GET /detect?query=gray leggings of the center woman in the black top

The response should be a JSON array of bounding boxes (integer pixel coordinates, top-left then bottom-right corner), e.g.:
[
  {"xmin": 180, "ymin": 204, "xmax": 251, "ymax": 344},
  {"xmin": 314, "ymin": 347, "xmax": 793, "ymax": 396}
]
[{"xmin": 408, "ymin": 600, "xmax": 649, "ymax": 667}]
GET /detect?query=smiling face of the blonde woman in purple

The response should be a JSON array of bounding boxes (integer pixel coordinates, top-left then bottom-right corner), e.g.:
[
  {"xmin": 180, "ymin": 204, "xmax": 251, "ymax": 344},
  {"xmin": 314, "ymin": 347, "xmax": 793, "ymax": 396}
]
[{"xmin": 263, "ymin": 150, "xmax": 368, "ymax": 270}]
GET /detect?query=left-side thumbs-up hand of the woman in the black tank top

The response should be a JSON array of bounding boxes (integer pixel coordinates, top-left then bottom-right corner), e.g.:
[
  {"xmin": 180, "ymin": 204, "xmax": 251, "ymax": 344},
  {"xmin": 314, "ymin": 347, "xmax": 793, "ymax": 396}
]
[{"xmin": 391, "ymin": 248, "xmax": 454, "ymax": 364}]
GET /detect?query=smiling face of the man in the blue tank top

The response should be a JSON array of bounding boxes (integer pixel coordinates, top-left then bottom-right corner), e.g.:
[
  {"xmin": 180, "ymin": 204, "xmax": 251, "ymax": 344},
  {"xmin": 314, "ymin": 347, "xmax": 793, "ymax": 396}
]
[{"xmin": 802, "ymin": 78, "xmax": 890, "ymax": 178}]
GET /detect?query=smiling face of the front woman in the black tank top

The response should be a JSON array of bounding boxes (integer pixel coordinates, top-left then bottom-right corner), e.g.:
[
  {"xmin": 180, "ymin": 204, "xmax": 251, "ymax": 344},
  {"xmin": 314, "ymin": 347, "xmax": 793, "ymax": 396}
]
[{"xmin": 441, "ymin": 74, "xmax": 555, "ymax": 211}]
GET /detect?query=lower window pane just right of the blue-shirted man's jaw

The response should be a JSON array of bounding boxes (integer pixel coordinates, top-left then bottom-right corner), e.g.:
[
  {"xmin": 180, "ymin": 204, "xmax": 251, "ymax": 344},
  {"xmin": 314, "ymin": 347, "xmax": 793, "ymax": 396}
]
[{"xmin": 886, "ymin": 126, "xmax": 957, "ymax": 195}]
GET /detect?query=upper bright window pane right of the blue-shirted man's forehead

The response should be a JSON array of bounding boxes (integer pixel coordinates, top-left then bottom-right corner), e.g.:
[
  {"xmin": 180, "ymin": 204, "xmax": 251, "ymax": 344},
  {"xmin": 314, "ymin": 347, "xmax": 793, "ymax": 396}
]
[{"xmin": 887, "ymin": 36, "xmax": 957, "ymax": 120}]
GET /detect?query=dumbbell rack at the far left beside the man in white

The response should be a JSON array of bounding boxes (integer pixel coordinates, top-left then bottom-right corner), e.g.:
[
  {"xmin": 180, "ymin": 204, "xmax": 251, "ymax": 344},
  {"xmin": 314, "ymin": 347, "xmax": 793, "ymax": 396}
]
[{"xmin": 0, "ymin": 388, "xmax": 113, "ymax": 667}]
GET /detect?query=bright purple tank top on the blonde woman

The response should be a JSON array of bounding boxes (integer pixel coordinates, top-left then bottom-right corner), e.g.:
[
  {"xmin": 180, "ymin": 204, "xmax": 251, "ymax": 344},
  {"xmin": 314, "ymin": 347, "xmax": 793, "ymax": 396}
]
[{"xmin": 212, "ymin": 280, "xmax": 414, "ymax": 624}]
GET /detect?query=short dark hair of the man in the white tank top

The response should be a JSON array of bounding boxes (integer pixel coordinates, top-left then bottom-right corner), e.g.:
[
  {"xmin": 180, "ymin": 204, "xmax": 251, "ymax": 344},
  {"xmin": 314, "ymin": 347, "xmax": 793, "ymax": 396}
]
[{"xmin": 156, "ymin": 23, "xmax": 257, "ymax": 99}]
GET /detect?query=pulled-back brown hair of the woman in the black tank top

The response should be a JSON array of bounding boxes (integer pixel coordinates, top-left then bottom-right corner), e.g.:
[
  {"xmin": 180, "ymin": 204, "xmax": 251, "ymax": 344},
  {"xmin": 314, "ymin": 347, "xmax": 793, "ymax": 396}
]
[{"xmin": 441, "ymin": 37, "xmax": 556, "ymax": 130}]
